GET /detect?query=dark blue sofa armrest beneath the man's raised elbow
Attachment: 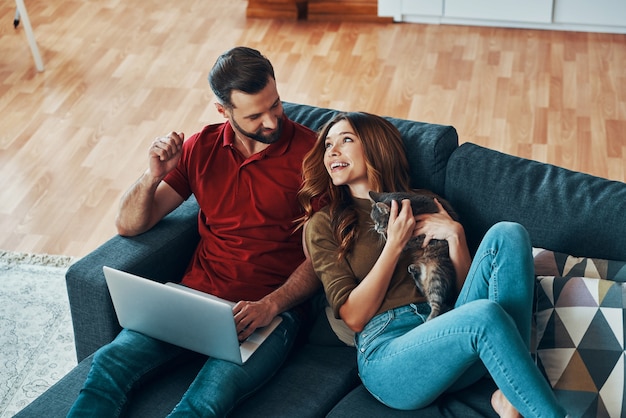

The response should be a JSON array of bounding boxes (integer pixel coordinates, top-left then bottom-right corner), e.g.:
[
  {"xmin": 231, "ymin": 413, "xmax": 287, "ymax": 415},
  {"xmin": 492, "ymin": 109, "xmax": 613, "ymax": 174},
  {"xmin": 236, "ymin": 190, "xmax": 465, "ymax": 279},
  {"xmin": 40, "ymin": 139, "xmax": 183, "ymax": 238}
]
[{"xmin": 65, "ymin": 197, "xmax": 199, "ymax": 362}]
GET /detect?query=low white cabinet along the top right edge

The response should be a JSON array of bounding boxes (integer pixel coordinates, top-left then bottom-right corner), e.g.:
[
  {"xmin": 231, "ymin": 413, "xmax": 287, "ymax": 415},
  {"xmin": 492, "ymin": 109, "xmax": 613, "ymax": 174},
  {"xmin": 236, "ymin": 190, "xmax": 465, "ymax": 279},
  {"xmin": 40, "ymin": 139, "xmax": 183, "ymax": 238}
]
[{"xmin": 378, "ymin": 0, "xmax": 626, "ymax": 34}]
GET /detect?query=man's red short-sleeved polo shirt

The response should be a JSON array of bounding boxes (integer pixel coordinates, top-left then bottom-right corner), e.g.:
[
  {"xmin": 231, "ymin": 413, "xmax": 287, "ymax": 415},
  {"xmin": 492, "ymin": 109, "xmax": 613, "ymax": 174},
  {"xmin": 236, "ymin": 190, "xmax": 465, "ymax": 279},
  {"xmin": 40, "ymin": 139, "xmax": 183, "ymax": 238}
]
[{"xmin": 165, "ymin": 117, "xmax": 315, "ymax": 301}]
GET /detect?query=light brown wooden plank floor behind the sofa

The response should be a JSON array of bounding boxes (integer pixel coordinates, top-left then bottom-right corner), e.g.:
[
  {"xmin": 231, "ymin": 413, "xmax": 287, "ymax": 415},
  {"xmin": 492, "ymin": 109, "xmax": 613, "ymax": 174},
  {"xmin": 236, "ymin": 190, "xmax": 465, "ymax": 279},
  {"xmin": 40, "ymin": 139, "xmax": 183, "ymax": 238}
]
[{"xmin": 0, "ymin": 0, "xmax": 626, "ymax": 256}]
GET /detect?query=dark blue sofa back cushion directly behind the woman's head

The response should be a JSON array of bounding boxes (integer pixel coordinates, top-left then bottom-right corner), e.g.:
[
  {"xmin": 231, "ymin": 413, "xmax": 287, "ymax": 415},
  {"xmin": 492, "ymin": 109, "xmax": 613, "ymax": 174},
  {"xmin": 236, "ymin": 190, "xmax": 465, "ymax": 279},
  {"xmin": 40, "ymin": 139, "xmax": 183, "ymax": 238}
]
[{"xmin": 283, "ymin": 102, "xmax": 459, "ymax": 195}]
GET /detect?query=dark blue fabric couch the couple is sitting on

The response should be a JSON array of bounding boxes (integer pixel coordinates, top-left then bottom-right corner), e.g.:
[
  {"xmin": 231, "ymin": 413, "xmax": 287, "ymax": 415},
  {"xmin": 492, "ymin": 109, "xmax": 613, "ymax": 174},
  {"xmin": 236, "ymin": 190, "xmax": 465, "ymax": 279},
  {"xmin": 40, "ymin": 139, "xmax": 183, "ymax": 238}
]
[{"xmin": 17, "ymin": 103, "xmax": 626, "ymax": 417}]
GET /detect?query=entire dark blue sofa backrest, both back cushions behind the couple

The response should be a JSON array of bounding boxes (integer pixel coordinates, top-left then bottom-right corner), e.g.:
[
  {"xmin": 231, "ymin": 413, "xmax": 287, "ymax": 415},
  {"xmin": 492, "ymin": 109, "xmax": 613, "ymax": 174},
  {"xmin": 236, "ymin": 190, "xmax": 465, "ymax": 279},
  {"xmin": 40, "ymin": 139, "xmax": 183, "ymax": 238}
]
[{"xmin": 283, "ymin": 102, "xmax": 626, "ymax": 260}]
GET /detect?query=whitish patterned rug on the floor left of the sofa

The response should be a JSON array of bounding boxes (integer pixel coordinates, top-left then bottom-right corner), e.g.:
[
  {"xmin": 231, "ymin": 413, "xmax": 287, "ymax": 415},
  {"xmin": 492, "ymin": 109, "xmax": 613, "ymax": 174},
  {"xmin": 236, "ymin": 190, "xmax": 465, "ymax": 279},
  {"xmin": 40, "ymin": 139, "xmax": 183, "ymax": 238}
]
[{"xmin": 0, "ymin": 250, "xmax": 76, "ymax": 418}]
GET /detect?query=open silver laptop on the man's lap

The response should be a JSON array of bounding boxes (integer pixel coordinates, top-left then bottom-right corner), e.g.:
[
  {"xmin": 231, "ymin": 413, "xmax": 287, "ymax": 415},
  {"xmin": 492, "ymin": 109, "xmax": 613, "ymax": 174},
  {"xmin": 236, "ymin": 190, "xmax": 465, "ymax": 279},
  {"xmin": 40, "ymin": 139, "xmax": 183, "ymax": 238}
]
[{"xmin": 103, "ymin": 266, "xmax": 282, "ymax": 364}]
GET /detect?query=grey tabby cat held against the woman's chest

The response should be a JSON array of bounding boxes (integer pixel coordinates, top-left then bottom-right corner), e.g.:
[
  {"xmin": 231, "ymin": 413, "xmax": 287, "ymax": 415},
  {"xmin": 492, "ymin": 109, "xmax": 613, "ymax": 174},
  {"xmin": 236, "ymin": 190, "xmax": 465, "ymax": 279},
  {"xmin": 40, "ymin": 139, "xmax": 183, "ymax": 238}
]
[{"xmin": 369, "ymin": 190, "xmax": 459, "ymax": 321}]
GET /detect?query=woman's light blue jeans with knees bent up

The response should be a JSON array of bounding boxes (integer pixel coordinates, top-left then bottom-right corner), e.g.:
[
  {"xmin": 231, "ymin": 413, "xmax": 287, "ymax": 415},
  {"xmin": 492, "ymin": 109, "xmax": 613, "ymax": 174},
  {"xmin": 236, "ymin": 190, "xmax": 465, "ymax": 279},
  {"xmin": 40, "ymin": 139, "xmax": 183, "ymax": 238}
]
[{"xmin": 356, "ymin": 222, "xmax": 565, "ymax": 418}]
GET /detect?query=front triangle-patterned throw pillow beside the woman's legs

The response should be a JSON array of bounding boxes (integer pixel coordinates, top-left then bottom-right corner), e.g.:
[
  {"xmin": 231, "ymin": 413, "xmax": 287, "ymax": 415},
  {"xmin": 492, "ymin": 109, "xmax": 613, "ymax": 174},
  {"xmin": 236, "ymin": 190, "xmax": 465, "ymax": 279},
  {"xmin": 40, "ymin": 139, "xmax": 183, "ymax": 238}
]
[{"xmin": 535, "ymin": 276, "xmax": 626, "ymax": 417}]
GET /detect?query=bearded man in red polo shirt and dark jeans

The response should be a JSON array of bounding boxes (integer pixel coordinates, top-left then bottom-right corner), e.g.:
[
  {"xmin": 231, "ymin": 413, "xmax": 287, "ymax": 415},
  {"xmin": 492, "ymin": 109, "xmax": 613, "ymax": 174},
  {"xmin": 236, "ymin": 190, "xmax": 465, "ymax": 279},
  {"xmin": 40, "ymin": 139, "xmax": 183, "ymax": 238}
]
[{"xmin": 69, "ymin": 47, "xmax": 319, "ymax": 417}]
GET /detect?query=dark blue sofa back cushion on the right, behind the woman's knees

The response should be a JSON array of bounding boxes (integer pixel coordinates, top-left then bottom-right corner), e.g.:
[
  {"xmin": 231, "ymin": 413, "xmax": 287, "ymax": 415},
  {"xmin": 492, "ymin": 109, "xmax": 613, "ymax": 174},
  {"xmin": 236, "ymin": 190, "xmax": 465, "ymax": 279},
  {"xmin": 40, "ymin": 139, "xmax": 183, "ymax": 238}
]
[{"xmin": 444, "ymin": 143, "xmax": 626, "ymax": 260}]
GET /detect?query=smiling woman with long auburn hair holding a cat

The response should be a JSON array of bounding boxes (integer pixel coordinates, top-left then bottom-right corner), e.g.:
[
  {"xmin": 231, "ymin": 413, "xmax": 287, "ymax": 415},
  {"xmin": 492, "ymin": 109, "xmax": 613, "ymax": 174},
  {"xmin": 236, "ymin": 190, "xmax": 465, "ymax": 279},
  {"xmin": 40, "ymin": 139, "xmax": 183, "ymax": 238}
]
[{"xmin": 299, "ymin": 113, "xmax": 566, "ymax": 417}]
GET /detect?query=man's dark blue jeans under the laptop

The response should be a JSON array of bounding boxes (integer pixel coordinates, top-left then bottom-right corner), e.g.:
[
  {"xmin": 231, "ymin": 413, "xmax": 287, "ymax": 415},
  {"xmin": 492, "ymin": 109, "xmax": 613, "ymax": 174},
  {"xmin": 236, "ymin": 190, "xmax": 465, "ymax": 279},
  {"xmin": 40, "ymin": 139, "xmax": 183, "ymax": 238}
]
[{"xmin": 68, "ymin": 312, "xmax": 300, "ymax": 417}]
